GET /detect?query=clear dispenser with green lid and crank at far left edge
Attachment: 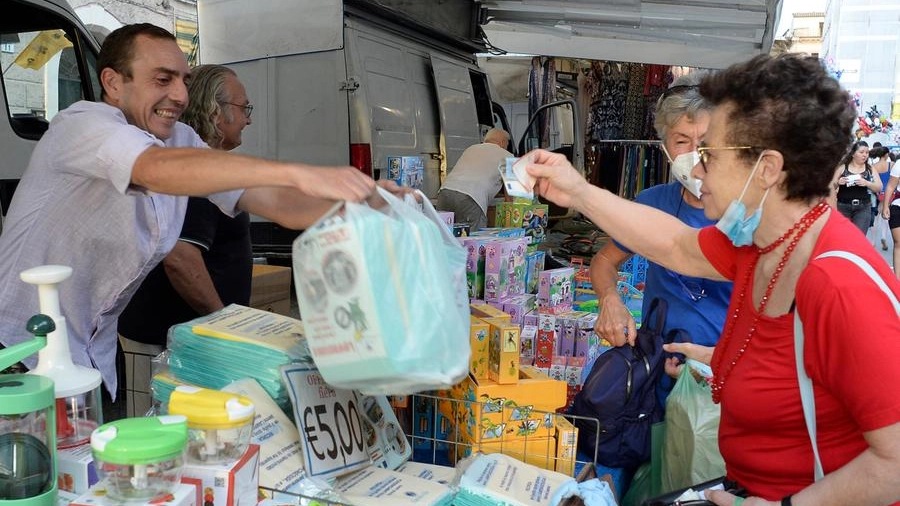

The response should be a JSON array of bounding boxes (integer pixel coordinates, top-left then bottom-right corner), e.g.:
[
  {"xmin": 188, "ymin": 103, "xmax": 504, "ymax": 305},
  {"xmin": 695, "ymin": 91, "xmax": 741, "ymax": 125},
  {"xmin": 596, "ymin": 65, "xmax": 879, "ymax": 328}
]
[{"xmin": 0, "ymin": 315, "xmax": 57, "ymax": 506}]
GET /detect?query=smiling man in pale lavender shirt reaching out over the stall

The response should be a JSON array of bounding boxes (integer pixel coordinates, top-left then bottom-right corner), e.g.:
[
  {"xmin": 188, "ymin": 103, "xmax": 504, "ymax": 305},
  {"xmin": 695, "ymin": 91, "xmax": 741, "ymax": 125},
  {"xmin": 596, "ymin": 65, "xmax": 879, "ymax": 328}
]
[{"xmin": 0, "ymin": 24, "xmax": 375, "ymax": 392}]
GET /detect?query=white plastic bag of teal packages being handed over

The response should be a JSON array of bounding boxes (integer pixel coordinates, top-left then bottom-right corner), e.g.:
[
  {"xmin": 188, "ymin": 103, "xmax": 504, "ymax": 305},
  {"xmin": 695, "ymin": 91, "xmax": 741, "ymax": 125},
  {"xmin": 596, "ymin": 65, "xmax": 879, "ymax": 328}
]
[{"xmin": 293, "ymin": 188, "xmax": 470, "ymax": 395}]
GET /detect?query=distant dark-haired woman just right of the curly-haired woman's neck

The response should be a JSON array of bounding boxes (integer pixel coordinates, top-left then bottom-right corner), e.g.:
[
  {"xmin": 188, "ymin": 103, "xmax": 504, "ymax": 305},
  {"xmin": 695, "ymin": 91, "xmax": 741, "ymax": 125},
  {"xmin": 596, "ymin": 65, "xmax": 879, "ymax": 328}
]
[{"xmin": 831, "ymin": 141, "xmax": 881, "ymax": 234}]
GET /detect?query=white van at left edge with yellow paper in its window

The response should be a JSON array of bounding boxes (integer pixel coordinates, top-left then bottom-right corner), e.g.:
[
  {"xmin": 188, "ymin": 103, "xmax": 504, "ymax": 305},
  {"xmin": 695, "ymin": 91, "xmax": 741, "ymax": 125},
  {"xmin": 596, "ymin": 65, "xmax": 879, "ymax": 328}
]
[{"xmin": 0, "ymin": 0, "xmax": 100, "ymax": 229}]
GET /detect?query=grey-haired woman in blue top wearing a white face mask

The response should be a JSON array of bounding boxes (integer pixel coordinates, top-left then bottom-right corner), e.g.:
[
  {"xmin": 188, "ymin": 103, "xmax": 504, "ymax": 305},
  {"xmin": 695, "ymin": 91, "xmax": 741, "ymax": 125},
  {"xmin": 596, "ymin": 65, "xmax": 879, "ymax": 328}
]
[{"xmin": 590, "ymin": 72, "xmax": 732, "ymax": 409}]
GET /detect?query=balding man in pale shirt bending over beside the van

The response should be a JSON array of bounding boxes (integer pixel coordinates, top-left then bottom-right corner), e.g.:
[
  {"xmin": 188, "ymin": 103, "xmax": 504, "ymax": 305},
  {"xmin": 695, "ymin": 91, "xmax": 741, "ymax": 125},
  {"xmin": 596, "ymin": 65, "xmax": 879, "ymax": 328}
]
[{"xmin": 437, "ymin": 128, "xmax": 513, "ymax": 231}]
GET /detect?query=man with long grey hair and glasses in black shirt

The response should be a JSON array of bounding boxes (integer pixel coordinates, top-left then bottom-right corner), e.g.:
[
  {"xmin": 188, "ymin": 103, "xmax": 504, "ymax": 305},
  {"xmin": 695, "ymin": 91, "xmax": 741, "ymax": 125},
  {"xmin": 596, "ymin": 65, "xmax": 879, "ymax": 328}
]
[{"xmin": 118, "ymin": 65, "xmax": 253, "ymax": 416}]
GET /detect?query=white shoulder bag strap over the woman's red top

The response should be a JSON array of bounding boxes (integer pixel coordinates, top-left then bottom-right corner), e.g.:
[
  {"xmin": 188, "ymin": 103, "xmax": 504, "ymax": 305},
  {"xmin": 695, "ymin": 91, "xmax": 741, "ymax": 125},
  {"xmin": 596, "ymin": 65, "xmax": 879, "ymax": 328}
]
[{"xmin": 794, "ymin": 251, "xmax": 900, "ymax": 481}]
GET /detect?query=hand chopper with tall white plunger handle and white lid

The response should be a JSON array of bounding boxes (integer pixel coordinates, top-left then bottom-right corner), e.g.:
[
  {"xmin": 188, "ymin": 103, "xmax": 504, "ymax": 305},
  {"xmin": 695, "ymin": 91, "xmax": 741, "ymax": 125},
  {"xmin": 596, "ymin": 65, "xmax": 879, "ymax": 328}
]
[{"xmin": 19, "ymin": 265, "xmax": 103, "ymax": 448}]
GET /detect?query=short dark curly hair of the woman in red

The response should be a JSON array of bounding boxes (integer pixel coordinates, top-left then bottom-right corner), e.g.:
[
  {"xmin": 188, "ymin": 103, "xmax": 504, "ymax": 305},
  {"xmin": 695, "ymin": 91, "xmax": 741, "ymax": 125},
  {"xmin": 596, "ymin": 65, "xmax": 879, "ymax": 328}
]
[{"xmin": 700, "ymin": 53, "xmax": 856, "ymax": 201}]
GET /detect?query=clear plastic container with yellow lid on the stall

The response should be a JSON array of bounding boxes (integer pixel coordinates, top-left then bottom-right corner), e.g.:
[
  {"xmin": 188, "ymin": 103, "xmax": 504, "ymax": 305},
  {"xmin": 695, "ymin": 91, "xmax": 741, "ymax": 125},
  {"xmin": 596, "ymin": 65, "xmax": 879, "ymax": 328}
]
[{"xmin": 169, "ymin": 385, "xmax": 255, "ymax": 464}]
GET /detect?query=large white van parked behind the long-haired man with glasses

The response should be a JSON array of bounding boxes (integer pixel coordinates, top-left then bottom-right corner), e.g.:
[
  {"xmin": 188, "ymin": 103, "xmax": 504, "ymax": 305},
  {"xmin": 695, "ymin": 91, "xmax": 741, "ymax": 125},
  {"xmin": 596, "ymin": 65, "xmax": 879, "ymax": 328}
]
[{"xmin": 198, "ymin": 0, "xmax": 502, "ymax": 257}]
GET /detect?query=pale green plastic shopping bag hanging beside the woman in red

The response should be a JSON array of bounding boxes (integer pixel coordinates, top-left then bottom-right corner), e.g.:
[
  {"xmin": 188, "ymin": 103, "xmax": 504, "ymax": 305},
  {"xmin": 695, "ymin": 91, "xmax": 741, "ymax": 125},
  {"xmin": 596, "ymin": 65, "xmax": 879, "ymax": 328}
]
[{"xmin": 661, "ymin": 363, "xmax": 725, "ymax": 491}]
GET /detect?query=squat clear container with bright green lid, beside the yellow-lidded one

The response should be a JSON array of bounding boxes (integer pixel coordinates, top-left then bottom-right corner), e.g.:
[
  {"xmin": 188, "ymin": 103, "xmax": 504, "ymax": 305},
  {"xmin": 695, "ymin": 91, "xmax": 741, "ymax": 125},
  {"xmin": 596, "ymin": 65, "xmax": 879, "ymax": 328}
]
[{"xmin": 91, "ymin": 415, "xmax": 187, "ymax": 501}]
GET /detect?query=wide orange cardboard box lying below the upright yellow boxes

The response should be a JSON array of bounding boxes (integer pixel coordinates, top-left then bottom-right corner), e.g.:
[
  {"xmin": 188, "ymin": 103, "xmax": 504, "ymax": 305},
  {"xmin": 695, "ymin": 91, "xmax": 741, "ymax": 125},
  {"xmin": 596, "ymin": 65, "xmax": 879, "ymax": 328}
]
[{"xmin": 439, "ymin": 366, "xmax": 566, "ymax": 443}]
